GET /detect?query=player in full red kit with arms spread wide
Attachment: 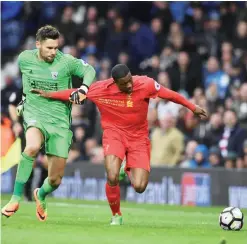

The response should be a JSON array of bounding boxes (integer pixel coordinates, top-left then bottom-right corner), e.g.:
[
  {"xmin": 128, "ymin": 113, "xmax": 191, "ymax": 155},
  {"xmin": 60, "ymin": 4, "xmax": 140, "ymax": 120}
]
[{"xmin": 33, "ymin": 64, "xmax": 207, "ymax": 225}]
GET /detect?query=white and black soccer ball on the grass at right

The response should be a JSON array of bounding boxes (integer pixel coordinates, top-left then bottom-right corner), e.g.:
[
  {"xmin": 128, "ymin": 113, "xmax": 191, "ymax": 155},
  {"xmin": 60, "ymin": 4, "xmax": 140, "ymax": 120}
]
[{"xmin": 219, "ymin": 207, "xmax": 244, "ymax": 230}]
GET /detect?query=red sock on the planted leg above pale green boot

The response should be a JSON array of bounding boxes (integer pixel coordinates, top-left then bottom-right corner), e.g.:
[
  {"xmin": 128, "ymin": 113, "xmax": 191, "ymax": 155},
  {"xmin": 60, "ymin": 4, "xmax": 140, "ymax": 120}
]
[{"xmin": 105, "ymin": 183, "xmax": 122, "ymax": 215}]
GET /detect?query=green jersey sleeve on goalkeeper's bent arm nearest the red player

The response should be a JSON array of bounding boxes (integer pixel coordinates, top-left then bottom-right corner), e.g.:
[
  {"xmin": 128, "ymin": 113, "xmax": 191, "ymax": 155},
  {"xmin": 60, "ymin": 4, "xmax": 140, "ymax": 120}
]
[{"xmin": 66, "ymin": 54, "xmax": 96, "ymax": 86}]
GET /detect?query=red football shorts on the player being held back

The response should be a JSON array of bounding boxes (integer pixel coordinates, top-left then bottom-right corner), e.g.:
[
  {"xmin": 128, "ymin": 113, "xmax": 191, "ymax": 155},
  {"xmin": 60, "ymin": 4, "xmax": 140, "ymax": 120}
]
[{"xmin": 103, "ymin": 129, "xmax": 150, "ymax": 172}]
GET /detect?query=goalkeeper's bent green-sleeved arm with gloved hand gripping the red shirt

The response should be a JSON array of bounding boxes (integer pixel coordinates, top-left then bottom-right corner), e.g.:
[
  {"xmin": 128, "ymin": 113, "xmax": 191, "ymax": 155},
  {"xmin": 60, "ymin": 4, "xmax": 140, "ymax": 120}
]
[{"xmin": 67, "ymin": 55, "xmax": 96, "ymax": 103}]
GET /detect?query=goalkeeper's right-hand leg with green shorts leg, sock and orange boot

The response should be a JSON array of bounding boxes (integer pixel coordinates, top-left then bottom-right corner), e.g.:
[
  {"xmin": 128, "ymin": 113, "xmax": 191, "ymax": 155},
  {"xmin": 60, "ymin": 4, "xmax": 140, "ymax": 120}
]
[{"xmin": 34, "ymin": 125, "xmax": 72, "ymax": 221}]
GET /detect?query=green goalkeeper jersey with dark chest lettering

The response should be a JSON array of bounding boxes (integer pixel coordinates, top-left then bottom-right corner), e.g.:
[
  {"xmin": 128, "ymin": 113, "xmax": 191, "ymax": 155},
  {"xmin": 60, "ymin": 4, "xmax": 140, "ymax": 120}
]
[{"xmin": 18, "ymin": 49, "xmax": 95, "ymax": 128}]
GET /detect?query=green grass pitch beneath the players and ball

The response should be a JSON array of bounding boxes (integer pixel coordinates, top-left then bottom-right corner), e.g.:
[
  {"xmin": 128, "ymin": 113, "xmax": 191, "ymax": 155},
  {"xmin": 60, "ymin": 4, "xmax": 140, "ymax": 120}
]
[{"xmin": 1, "ymin": 196, "xmax": 247, "ymax": 244}]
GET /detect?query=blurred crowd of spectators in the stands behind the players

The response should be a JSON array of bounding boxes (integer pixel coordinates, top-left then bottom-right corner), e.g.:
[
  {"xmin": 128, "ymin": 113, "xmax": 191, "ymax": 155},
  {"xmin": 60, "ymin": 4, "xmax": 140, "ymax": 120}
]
[{"xmin": 1, "ymin": 1, "xmax": 247, "ymax": 169}]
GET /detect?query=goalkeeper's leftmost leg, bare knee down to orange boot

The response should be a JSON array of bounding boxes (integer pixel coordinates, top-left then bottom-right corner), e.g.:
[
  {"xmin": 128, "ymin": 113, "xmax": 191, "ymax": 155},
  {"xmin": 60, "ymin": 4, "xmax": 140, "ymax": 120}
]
[{"xmin": 2, "ymin": 127, "xmax": 44, "ymax": 217}]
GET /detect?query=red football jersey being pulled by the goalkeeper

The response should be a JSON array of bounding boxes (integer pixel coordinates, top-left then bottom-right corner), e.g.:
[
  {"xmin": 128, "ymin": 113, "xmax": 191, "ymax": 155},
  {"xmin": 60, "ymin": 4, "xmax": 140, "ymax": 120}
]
[{"xmin": 87, "ymin": 76, "xmax": 160, "ymax": 138}]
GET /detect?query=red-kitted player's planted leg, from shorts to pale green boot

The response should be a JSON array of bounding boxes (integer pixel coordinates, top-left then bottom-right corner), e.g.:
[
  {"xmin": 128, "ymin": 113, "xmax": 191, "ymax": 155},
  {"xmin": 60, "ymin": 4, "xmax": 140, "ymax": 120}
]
[{"xmin": 103, "ymin": 130, "xmax": 125, "ymax": 225}]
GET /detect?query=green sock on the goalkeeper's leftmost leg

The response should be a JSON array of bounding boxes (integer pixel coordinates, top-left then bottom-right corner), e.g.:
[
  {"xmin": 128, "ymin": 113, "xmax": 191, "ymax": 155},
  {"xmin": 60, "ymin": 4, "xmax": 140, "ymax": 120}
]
[{"xmin": 10, "ymin": 152, "xmax": 34, "ymax": 202}]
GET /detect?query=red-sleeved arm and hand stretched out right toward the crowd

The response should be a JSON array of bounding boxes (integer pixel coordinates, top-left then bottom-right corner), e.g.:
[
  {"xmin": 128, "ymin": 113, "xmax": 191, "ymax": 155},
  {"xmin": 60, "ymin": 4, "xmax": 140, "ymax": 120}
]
[{"xmin": 158, "ymin": 86, "xmax": 207, "ymax": 118}]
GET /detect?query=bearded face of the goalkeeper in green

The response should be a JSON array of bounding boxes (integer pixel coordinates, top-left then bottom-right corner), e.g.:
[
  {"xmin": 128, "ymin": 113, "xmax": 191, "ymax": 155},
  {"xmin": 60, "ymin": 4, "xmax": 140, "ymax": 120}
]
[{"xmin": 36, "ymin": 39, "xmax": 58, "ymax": 63}]
